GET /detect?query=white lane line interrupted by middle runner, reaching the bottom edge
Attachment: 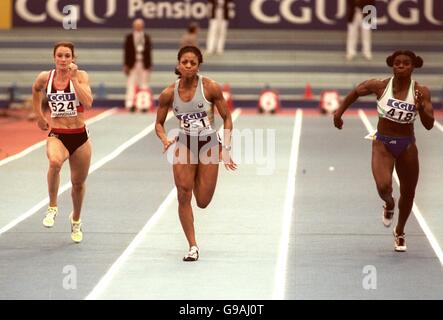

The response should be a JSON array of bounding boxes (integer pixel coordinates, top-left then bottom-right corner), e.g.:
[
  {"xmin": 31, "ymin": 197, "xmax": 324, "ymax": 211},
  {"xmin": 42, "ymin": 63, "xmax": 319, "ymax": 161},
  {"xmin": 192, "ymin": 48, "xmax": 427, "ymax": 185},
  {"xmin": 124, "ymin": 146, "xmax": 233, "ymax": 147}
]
[{"xmin": 85, "ymin": 108, "xmax": 241, "ymax": 300}]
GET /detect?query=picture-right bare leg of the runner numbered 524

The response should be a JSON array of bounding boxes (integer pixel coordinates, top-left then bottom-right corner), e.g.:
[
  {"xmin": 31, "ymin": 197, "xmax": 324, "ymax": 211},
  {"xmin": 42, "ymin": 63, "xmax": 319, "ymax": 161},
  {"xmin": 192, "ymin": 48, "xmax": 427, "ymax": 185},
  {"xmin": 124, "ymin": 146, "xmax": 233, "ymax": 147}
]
[{"xmin": 69, "ymin": 140, "xmax": 92, "ymax": 221}]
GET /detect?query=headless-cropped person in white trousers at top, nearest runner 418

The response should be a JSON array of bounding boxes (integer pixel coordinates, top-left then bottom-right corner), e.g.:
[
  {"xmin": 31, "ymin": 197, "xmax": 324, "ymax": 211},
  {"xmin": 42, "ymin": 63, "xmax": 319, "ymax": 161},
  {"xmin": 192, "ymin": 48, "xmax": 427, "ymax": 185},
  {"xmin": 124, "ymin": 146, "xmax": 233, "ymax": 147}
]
[{"xmin": 346, "ymin": 0, "xmax": 375, "ymax": 60}]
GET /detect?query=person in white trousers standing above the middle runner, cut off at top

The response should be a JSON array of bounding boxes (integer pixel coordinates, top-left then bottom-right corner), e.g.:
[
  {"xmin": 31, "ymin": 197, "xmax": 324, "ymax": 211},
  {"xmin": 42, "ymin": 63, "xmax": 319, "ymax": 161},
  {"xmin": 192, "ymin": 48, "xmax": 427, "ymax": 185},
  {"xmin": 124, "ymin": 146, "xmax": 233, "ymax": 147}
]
[{"xmin": 206, "ymin": 0, "xmax": 232, "ymax": 54}]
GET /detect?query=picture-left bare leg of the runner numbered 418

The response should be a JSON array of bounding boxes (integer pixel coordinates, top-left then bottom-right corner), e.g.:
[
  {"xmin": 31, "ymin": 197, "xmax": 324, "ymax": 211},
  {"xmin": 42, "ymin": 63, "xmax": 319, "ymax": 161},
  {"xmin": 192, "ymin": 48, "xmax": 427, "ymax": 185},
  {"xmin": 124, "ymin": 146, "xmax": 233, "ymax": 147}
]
[{"xmin": 372, "ymin": 140, "xmax": 395, "ymax": 210}]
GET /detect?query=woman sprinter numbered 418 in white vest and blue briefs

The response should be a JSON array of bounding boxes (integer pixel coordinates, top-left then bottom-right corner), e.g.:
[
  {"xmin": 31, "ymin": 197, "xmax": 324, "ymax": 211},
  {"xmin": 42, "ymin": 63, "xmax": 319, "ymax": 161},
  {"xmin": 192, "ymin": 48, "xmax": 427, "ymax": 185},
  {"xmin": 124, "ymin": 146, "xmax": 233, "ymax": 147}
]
[{"xmin": 334, "ymin": 50, "xmax": 434, "ymax": 252}]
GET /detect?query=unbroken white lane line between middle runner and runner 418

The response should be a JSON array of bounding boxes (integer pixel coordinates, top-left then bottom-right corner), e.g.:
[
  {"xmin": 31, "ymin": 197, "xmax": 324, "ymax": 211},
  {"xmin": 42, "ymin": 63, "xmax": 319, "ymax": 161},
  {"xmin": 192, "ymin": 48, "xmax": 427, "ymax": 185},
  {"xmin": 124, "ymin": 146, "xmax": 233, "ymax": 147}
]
[{"xmin": 272, "ymin": 109, "xmax": 303, "ymax": 300}]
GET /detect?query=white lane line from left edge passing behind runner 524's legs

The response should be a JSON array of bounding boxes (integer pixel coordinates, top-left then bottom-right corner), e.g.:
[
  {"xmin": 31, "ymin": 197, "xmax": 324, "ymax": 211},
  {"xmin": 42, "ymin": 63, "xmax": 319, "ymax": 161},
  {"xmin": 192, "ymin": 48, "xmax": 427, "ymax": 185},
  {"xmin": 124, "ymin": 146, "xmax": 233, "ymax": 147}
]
[{"xmin": 0, "ymin": 112, "xmax": 172, "ymax": 235}]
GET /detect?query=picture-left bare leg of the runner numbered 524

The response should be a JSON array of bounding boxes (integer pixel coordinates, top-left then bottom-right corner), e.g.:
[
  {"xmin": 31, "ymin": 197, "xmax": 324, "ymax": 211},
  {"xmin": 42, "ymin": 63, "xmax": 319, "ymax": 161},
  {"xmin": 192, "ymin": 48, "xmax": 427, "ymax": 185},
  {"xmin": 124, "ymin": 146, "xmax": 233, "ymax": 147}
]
[{"xmin": 46, "ymin": 137, "xmax": 69, "ymax": 207}]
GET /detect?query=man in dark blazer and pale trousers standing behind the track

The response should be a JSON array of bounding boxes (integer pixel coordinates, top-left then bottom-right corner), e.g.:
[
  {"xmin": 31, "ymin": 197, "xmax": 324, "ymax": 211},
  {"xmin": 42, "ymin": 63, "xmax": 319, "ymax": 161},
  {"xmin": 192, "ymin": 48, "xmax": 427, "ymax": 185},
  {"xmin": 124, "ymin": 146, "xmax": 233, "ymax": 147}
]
[{"xmin": 124, "ymin": 19, "xmax": 152, "ymax": 112}]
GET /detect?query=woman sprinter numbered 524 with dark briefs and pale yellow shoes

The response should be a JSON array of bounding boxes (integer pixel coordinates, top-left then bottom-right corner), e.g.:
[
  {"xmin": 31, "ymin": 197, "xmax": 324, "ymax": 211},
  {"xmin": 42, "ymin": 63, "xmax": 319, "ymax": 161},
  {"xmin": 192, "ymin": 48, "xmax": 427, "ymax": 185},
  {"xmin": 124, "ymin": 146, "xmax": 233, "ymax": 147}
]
[{"xmin": 32, "ymin": 42, "xmax": 93, "ymax": 243}]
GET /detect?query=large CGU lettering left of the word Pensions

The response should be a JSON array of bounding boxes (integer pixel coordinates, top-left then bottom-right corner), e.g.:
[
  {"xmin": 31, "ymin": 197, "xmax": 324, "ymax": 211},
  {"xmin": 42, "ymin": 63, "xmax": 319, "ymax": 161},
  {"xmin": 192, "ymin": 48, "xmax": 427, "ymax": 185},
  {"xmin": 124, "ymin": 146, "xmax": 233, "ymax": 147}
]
[{"xmin": 15, "ymin": 0, "xmax": 117, "ymax": 24}]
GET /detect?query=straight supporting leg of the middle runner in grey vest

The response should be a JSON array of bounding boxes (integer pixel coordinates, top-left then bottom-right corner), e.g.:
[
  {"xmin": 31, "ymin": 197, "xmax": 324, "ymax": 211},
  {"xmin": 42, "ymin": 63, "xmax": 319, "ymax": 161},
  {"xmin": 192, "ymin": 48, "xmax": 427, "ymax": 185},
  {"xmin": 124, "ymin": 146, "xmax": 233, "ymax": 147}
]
[{"xmin": 172, "ymin": 143, "xmax": 197, "ymax": 247}]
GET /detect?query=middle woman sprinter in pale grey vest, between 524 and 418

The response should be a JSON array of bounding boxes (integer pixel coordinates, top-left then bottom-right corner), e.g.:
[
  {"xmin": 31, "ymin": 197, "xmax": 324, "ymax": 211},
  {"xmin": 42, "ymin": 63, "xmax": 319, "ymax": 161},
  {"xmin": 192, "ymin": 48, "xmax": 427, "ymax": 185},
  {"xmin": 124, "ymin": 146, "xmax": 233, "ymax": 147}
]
[{"xmin": 155, "ymin": 46, "xmax": 237, "ymax": 261}]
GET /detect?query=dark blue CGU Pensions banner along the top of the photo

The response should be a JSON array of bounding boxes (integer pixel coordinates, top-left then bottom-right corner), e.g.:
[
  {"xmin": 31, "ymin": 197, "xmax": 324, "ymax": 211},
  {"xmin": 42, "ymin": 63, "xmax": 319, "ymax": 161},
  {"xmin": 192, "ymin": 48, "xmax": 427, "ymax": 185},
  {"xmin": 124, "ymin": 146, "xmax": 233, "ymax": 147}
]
[{"xmin": 9, "ymin": 0, "xmax": 443, "ymax": 30}]
